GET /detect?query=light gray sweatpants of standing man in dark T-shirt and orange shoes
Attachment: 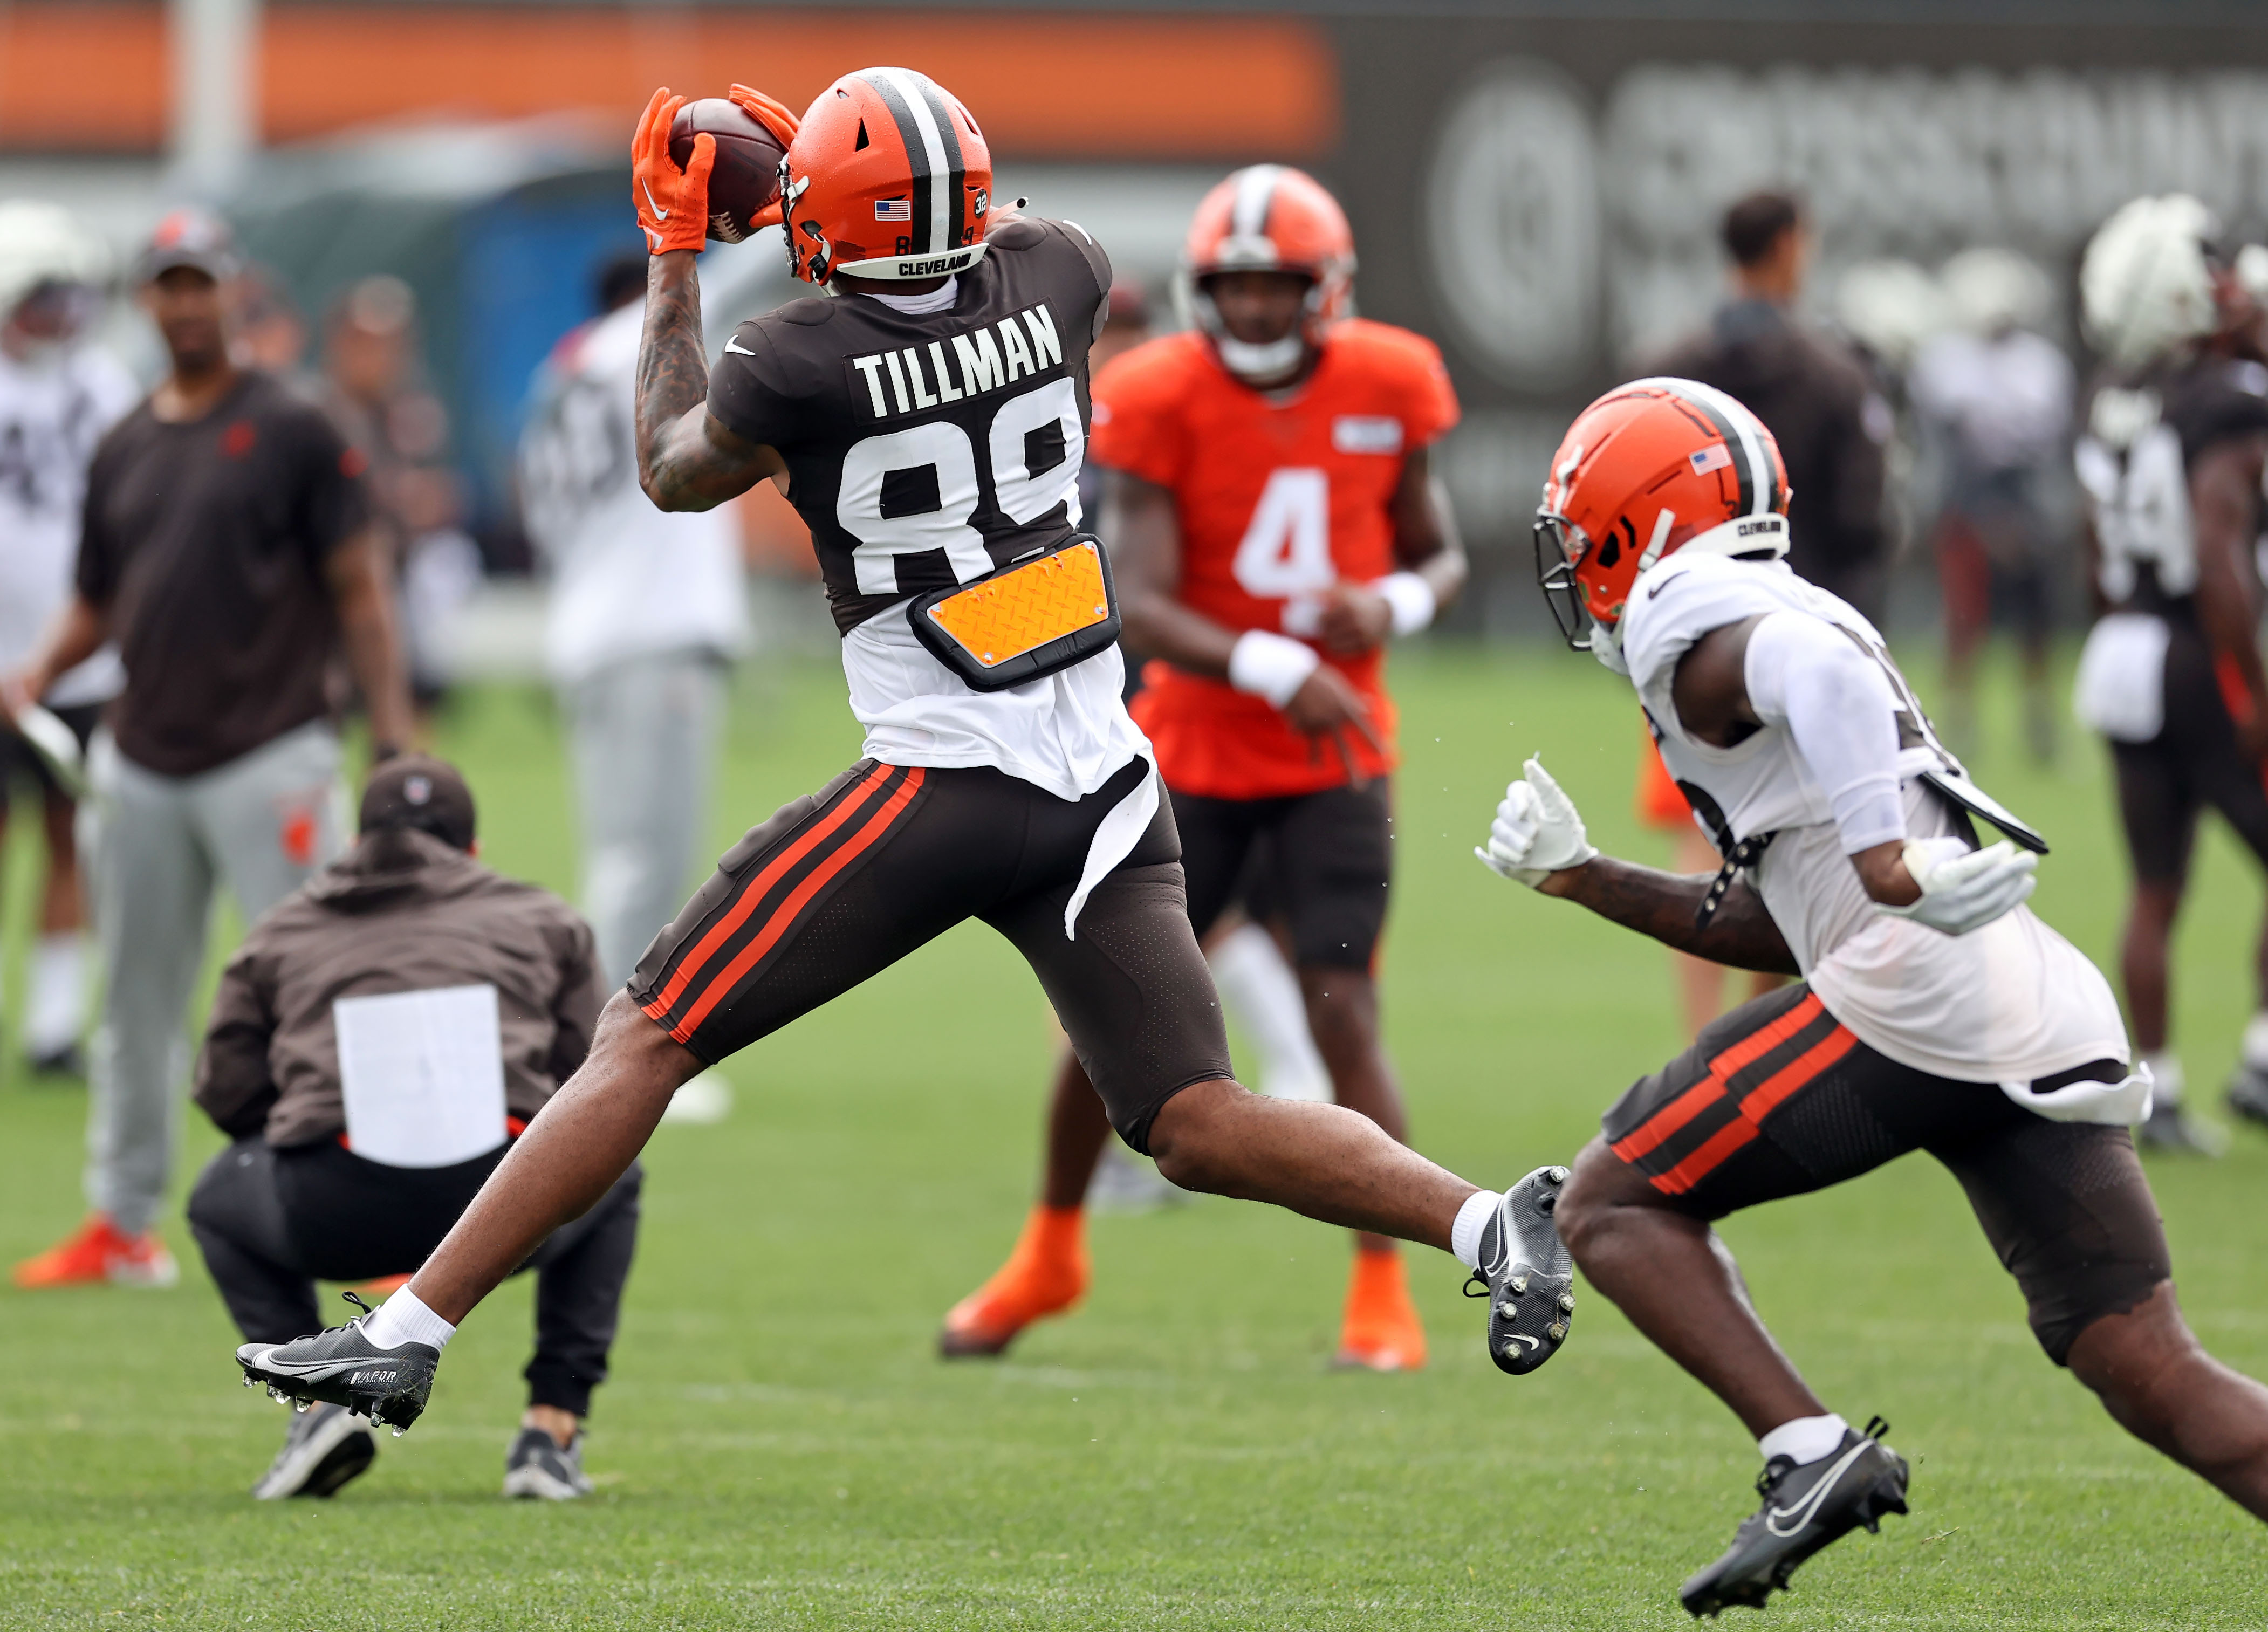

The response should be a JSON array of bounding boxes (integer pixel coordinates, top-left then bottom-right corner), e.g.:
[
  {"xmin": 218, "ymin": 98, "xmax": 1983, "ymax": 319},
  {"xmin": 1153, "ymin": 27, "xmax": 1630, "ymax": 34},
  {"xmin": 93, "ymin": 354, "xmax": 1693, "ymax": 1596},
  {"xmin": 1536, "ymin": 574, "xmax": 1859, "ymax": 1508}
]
[{"xmin": 79, "ymin": 721, "xmax": 345, "ymax": 1233}]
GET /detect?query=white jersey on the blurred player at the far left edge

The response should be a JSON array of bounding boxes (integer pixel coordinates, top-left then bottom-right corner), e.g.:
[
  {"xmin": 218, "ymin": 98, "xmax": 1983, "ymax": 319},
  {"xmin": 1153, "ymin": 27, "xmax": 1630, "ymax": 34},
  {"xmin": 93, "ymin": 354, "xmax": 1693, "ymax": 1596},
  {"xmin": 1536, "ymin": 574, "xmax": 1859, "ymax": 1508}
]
[{"xmin": 0, "ymin": 345, "xmax": 141, "ymax": 707}]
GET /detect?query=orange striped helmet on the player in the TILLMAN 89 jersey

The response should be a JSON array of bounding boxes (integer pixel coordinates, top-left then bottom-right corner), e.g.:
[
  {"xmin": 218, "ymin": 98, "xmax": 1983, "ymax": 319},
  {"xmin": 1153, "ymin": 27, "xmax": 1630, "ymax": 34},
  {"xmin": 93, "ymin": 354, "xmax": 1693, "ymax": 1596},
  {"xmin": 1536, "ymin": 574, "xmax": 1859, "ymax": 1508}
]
[{"xmin": 780, "ymin": 68, "xmax": 991, "ymax": 286}]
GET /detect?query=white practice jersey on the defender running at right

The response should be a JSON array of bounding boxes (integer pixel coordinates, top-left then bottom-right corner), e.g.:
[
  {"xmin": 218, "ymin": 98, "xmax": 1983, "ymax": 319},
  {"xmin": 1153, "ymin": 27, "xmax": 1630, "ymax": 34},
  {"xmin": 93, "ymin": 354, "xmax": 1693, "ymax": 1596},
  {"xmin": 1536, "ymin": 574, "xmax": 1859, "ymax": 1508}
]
[{"xmin": 1622, "ymin": 556, "xmax": 2127, "ymax": 1084}]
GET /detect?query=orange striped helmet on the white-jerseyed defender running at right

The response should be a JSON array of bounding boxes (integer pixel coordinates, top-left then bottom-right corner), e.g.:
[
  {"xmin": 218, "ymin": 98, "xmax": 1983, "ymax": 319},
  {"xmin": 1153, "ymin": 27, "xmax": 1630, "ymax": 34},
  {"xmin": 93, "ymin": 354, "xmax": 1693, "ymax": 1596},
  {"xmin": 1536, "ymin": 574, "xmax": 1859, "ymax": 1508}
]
[{"xmin": 1536, "ymin": 379, "xmax": 1790, "ymax": 667}]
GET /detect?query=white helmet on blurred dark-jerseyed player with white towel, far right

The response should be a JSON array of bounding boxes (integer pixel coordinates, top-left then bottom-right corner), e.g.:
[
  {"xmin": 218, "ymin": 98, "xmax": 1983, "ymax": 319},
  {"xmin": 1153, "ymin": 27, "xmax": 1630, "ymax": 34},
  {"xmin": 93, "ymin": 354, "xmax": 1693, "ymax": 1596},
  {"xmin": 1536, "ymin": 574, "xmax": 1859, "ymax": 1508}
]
[{"xmin": 2080, "ymin": 193, "xmax": 2221, "ymax": 369}]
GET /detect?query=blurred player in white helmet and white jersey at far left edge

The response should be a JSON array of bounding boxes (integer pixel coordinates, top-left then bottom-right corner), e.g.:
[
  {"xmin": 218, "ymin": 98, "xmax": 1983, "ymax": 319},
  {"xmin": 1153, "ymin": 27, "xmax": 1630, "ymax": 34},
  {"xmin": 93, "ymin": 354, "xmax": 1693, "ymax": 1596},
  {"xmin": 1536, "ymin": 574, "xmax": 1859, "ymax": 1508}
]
[{"xmin": 0, "ymin": 200, "xmax": 139, "ymax": 1074}]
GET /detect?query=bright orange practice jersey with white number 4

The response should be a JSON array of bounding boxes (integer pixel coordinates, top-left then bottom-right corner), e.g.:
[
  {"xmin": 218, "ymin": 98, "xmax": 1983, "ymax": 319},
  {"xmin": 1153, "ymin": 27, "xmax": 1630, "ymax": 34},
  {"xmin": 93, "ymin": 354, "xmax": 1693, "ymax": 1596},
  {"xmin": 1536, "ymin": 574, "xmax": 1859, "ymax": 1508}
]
[{"xmin": 1093, "ymin": 317, "xmax": 1456, "ymax": 798}]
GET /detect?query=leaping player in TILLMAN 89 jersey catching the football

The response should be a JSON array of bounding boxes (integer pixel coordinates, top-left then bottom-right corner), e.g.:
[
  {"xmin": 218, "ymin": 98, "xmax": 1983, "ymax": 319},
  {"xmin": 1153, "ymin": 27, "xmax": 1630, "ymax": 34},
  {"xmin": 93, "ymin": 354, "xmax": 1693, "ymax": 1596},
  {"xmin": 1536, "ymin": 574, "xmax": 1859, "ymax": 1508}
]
[{"xmin": 238, "ymin": 68, "xmax": 1574, "ymax": 1428}]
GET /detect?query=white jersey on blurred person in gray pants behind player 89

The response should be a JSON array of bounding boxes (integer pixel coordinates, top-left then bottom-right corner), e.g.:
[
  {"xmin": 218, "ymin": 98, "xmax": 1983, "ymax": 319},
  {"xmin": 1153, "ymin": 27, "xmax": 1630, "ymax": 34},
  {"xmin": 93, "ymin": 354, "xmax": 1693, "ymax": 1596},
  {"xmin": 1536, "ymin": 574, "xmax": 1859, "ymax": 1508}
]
[{"xmin": 519, "ymin": 301, "xmax": 749, "ymax": 684}]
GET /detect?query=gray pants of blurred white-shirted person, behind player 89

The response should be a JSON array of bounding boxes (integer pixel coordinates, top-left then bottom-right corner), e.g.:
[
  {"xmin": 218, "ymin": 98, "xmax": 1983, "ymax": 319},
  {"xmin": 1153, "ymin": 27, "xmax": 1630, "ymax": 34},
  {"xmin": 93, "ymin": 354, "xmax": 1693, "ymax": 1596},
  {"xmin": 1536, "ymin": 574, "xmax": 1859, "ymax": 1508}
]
[{"xmin": 563, "ymin": 648, "xmax": 726, "ymax": 986}]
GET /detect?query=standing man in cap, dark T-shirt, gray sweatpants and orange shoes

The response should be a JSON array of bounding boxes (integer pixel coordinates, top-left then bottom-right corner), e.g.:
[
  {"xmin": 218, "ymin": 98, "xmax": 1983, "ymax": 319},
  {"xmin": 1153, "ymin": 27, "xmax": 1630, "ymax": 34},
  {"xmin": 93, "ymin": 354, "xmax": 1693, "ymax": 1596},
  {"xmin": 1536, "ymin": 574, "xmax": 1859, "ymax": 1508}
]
[{"xmin": 0, "ymin": 211, "xmax": 408, "ymax": 1285}]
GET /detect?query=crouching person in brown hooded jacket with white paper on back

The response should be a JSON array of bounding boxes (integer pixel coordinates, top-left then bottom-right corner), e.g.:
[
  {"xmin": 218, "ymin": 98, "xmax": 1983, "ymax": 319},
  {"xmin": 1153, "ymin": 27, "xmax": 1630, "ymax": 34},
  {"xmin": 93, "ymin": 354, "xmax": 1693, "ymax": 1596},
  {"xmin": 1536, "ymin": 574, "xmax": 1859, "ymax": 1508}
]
[{"xmin": 188, "ymin": 757, "xmax": 640, "ymax": 1500}]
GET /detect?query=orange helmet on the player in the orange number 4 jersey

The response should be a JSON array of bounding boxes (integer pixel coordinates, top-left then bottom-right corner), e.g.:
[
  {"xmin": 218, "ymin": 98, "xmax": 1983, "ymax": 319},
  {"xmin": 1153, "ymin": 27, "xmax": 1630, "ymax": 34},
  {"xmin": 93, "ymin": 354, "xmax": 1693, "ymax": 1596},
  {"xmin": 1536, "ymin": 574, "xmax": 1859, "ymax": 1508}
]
[{"xmin": 1177, "ymin": 166, "xmax": 1354, "ymax": 379}]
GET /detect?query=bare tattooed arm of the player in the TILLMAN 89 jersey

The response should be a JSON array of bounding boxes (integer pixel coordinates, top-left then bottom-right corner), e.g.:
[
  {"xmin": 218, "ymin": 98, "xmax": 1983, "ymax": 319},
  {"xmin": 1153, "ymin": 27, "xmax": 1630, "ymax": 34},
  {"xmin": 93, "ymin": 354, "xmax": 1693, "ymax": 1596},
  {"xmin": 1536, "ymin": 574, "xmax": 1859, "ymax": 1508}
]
[{"xmin": 638, "ymin": 249, "xmax": 787, "ymax": 510}]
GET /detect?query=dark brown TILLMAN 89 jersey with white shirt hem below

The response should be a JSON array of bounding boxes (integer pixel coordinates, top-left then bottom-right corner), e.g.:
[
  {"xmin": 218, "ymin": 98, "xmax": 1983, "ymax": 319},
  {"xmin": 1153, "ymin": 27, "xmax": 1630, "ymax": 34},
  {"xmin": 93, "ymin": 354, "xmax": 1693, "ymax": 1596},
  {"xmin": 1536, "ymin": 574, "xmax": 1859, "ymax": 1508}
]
[{"xmin": 710, "ymin": 217, "xmax": 1146, "ymax": 798}]
